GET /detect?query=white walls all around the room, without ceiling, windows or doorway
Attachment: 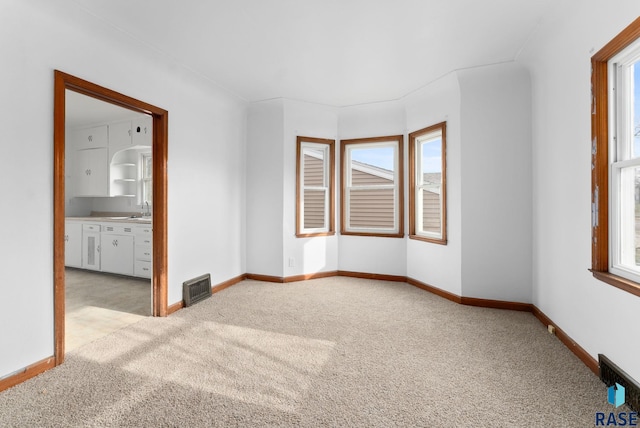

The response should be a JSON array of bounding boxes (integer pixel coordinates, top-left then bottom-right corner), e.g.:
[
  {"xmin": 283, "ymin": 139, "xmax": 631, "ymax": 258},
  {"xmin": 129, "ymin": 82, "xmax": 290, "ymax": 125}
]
[{"xmin": 5, "ymin": 0, "xmax": 640, "ymax": 386}]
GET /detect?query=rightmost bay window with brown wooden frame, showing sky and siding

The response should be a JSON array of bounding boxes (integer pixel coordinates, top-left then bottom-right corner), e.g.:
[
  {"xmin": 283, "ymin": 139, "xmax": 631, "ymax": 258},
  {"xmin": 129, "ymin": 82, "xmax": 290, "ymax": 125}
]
[{"xmin": 409, "ymin": 122, "xmax": 447, "ymax": 245}]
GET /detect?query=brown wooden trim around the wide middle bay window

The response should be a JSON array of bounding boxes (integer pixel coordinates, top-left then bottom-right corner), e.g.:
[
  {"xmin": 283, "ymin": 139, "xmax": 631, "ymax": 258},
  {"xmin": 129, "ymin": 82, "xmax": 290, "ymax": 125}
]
[{"xmin": 340, "ymin": 135, "xmax": 404, "ymax": 238}]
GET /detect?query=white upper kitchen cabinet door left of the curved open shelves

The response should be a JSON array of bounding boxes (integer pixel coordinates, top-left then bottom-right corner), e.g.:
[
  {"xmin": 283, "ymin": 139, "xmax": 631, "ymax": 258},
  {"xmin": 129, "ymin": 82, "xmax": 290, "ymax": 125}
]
[{"xmin": 73, "ymin": 148, "xmax": 109, "ymax": 196}]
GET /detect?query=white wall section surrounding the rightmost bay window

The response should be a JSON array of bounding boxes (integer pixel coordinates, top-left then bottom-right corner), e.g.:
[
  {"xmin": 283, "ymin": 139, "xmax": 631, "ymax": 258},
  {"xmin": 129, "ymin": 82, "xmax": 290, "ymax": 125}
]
[{"xmin": 404, "ymin": 73, "xmax": 462, "ymax": 296}]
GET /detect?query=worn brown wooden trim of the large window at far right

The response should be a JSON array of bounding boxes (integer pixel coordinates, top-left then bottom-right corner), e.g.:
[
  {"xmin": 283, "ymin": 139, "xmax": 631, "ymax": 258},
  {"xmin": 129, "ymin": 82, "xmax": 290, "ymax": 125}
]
[{"xmin": 590, "ymin": 18, "xmax": 640, "ymax": 296}]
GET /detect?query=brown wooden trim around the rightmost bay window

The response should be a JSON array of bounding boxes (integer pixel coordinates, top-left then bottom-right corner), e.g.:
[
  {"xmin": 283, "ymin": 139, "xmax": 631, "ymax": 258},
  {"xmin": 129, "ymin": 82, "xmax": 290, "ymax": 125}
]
[{"xmin": 409, "ymin": 122, "xmax": 447, "ymax": 245}]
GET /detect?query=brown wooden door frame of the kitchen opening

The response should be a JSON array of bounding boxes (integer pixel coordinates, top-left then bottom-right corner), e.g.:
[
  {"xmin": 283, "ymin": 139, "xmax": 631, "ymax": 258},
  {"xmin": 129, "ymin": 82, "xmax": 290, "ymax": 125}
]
[{"xmin": 53, "ymin": 70, "xmax": 169, "ymax": 365}]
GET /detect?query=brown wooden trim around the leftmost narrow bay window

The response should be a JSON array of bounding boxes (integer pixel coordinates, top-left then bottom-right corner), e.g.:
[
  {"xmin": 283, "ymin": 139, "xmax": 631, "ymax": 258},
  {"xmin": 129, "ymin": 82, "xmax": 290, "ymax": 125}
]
[{"xmin": 296, "ymin": 136, "xmax": 336, "ymax": 238}]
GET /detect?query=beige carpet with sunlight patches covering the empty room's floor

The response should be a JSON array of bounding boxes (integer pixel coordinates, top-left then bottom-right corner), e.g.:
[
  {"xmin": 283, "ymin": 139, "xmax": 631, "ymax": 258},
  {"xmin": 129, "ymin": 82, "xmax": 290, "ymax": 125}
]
[{"xmin": 0, "ymin": 277, "xmax": 623, "ymax": 427}]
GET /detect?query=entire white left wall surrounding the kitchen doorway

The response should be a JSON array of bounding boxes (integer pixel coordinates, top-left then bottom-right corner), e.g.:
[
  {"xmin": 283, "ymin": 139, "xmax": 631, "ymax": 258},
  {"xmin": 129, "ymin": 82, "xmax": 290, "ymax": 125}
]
[{"xmin": 0, "ymin": 0, "xmax": 246, "ymax": 377}]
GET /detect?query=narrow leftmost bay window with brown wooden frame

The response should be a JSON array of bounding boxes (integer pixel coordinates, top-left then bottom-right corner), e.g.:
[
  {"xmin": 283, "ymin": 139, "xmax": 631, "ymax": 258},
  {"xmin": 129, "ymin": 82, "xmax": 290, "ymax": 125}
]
[{"xmin": 296, "ymin": 137, "xmax": 335, "ymax": 237}]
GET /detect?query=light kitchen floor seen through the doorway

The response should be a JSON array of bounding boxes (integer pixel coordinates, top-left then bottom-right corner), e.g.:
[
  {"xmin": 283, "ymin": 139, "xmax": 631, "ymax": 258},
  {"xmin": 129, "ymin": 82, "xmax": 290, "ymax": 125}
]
[{"xmin": 65, "ymin": 268, "xmax": 151, "ymax": 352}]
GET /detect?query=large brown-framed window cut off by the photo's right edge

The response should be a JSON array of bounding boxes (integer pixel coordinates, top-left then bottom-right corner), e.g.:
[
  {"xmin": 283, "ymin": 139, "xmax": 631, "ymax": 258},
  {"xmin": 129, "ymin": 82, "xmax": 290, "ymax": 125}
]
[{"xmin": 591, "ymin": 18, "xmax": 640, "ymax": 295}]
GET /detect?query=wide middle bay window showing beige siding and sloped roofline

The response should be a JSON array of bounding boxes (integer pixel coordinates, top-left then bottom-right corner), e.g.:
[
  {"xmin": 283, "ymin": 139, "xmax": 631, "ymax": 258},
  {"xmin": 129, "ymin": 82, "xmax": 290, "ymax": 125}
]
[{"xmin": 341, "ymin": 135, "xmax": 404, "ymax": 237}]
